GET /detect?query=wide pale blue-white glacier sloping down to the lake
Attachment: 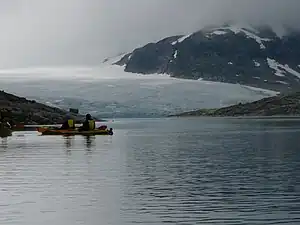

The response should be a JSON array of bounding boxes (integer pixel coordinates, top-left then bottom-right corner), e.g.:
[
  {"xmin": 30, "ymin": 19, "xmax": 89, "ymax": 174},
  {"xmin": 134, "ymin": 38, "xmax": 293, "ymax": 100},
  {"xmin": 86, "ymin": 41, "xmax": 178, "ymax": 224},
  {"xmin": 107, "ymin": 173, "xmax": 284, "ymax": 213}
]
[{"xmin": 0, "ymin": 56, "xmax": 278, "ymax": 118}]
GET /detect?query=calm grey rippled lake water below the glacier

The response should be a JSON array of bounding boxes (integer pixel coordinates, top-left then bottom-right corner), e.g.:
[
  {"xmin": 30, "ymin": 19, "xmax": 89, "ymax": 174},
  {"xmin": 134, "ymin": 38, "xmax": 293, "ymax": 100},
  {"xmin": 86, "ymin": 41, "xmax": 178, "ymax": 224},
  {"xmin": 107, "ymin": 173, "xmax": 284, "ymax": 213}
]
[{"xmin": 0, "ymin": 119, "xmax": 300, "ymax": 225}]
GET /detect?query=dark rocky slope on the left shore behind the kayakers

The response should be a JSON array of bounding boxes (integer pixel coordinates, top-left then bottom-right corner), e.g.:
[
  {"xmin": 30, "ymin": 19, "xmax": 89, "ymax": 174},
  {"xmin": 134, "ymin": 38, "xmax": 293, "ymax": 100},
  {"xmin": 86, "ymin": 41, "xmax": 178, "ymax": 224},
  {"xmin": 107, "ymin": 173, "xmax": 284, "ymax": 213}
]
[{"xmin": 0, "ymin": 91, "xmax": 96, "ymax": 125}]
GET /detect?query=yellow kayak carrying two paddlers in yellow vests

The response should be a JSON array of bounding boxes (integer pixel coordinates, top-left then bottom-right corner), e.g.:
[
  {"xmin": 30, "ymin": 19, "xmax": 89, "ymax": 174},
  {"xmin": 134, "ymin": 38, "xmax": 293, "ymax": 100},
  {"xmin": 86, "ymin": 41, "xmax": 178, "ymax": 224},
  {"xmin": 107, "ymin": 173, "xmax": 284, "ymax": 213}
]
[{"xmin": 37, "ymin": 127, "xmax": 113, "ymax": 135}]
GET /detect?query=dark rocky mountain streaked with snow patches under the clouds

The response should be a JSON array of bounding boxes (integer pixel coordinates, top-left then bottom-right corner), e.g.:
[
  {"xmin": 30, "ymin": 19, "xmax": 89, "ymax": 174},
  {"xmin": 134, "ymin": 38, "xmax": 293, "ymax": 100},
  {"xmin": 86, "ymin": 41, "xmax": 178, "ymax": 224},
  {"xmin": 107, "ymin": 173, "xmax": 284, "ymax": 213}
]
[{"xmin": 115, "ymin": 25, "xmax": 300, "ymax": 91}]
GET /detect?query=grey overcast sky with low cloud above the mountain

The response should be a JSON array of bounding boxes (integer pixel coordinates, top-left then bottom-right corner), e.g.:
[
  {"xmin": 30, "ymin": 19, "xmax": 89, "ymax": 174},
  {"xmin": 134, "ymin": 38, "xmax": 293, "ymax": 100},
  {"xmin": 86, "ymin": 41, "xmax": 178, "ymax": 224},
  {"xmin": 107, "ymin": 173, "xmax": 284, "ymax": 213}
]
[{"xmin": 0, "ymin": 0, "xmax": 300, "ymax": 68}]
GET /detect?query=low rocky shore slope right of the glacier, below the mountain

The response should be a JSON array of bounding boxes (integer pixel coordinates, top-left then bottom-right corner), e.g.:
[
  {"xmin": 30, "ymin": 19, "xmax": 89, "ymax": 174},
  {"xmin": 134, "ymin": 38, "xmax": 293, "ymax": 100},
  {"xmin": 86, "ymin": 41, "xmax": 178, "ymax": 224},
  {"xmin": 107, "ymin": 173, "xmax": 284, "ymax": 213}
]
[{"xmin": 169, "ymin": 92, "xmax": 300, "ymax": 117}]
